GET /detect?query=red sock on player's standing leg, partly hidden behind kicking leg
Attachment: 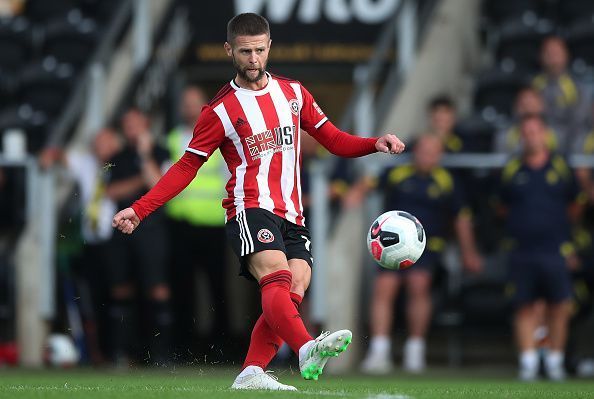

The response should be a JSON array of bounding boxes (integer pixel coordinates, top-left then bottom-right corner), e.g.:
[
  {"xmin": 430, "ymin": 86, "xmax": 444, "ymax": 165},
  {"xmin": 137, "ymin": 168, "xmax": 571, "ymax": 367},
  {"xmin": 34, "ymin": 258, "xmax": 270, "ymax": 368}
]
[{"xmin": 242, "ymin": 292, "xmax": 302, "ymax": 370}]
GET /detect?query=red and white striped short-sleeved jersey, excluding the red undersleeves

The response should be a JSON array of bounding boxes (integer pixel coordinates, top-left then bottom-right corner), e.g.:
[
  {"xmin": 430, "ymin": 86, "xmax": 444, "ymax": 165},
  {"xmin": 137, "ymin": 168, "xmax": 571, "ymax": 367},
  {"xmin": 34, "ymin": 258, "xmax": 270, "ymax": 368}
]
[{"xmin": 186, "ymin": 73, "xmax": 328, "ymax": 225}]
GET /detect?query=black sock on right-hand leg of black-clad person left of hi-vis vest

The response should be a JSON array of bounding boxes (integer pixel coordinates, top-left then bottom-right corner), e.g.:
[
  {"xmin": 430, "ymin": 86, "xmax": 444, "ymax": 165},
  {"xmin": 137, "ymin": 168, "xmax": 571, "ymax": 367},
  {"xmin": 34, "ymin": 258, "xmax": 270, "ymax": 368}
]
[{"xmin": 149, "ymin": 299, "xmax": 173, "ymax": 364}]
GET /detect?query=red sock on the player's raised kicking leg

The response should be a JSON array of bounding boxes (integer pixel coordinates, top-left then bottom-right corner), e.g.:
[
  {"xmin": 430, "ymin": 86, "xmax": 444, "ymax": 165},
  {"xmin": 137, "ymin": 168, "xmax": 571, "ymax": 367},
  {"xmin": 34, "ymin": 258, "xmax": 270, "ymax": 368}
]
[{"xmin": 260, "ymin": 270, "xmax": 312, "ymax": 353}]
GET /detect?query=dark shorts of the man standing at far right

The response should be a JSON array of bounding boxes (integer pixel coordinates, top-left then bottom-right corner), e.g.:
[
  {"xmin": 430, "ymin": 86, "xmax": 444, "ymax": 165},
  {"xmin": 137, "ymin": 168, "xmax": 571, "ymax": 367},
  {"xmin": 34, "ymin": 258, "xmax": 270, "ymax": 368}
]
[{"xmin": 508, "ymin": 251, "xmax": 572, "ymax": 306}]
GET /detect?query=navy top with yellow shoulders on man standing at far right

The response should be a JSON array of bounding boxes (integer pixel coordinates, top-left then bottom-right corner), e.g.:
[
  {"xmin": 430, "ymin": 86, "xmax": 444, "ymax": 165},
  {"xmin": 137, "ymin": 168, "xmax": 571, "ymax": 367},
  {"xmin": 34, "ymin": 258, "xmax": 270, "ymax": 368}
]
[{"xmin": 500, "ymin": 155, "xmax": 579, "ymax": 252}]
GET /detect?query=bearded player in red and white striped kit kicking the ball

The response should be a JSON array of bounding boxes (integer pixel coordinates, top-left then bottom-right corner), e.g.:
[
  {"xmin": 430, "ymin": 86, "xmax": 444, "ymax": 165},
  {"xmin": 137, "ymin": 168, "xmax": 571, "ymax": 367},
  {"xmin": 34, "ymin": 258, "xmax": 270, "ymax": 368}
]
[{"xmin": 113, "ymin": 13, "xmax": 404, "ymax": 390}]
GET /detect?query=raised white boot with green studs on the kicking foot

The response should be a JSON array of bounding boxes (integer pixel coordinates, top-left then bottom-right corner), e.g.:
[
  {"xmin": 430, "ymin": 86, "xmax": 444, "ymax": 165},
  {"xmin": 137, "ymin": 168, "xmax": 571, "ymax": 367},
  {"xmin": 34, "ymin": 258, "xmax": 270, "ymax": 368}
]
[{"xmin": 299, "ymin": 330, "xmax": 353, "ymax": 380}]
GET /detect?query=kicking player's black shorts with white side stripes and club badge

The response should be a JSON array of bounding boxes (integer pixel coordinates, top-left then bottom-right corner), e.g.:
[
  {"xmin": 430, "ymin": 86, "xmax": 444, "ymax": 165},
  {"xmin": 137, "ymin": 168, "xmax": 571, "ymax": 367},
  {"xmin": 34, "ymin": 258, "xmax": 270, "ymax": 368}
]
[{"xmin": 225, "ymin": 208, "xmax": 313, "ymax": 280}]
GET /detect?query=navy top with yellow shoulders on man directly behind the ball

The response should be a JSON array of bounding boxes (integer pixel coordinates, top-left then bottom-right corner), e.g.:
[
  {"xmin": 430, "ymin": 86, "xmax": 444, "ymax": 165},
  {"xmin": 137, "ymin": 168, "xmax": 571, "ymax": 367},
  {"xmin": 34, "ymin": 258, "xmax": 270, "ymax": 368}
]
[{"xmin": 379, "ymin": 165, "xmax": 466, "ymax": 242}]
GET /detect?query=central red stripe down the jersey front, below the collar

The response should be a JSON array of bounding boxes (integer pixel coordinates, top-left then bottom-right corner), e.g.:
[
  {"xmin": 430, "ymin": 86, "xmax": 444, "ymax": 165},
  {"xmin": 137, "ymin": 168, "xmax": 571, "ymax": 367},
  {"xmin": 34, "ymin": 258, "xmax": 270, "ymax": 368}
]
[{"xmin": 256, "ymin": 92, "xmax": 287, "ymax": 218}]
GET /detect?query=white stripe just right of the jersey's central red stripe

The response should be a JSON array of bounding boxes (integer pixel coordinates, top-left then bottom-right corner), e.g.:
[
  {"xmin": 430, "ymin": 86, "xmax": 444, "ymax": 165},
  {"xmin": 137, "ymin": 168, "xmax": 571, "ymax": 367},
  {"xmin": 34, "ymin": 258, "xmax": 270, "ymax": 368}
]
[{"xmin": 269, "ymin": 80, "xmax": 299, "ymax": 223}]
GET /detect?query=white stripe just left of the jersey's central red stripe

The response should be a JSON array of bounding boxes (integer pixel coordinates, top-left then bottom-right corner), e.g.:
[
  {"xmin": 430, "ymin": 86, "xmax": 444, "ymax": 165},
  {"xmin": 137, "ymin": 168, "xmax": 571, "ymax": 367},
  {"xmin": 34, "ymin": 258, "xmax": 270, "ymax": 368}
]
[{"xmin": 235, "ymin": 91, "xmax": 274, "ymax": 212}]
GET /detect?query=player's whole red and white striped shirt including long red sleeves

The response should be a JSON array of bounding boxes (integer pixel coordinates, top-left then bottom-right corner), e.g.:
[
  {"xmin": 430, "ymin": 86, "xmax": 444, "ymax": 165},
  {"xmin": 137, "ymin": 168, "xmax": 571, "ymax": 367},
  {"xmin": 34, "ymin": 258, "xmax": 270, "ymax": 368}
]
[{"xmin": 132, "ymin": 73, "xmax": 377, "ymax": 225}]
